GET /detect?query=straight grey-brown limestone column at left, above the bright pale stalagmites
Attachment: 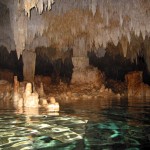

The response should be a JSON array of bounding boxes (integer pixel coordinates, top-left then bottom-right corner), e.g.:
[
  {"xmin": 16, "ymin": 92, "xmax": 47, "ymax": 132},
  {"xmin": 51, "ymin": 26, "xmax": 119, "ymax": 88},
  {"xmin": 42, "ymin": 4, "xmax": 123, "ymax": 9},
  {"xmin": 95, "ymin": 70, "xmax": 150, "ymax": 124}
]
[{"xmin": 22, "ymin": 51, "xmax": 36, "ymax": 82}]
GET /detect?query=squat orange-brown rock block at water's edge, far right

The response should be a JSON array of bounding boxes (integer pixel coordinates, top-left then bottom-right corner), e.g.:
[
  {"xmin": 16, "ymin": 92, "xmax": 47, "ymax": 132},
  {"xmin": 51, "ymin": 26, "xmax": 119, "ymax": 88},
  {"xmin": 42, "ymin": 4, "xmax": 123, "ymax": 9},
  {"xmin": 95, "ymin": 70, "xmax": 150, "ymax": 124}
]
[{"xmin": 126, "ymin": 71, "xmax": 150, "ymax": 98}]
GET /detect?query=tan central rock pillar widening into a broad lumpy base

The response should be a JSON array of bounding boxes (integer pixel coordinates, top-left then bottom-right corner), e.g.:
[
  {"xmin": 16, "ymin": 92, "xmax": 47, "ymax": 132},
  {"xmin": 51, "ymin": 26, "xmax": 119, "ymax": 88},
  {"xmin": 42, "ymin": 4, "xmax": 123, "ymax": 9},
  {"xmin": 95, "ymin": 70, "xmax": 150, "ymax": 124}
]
[{"xmin": 71, "ymin": 39, "xmax": 102, "ymax": 84}]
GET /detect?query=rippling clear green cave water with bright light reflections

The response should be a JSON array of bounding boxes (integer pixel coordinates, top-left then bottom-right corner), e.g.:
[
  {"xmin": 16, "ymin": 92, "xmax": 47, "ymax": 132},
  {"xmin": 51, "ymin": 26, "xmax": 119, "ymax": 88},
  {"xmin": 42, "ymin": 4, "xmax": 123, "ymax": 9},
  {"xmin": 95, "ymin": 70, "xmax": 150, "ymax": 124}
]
[{"xmin": 0, "ymin": 99, "xmax": 150, "ymax": 150}]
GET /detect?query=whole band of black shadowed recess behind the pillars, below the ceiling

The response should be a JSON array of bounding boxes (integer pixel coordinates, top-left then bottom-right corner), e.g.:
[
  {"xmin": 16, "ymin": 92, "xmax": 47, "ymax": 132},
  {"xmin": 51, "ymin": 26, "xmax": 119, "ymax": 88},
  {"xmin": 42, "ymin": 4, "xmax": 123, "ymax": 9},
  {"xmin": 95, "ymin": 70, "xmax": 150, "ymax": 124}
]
[{"xmin": 0, "ymin": 46, "xmax": 150, "ymax": 85}]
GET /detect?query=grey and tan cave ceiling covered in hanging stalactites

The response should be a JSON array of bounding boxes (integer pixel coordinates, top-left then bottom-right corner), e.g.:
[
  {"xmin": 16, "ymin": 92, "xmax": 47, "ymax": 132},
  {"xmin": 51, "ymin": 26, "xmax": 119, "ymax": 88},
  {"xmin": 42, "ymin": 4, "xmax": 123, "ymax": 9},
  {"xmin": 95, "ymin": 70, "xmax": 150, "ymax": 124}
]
[{"xmin": 0, "ymin": 0, "xmax": 150, "ymax": 70}]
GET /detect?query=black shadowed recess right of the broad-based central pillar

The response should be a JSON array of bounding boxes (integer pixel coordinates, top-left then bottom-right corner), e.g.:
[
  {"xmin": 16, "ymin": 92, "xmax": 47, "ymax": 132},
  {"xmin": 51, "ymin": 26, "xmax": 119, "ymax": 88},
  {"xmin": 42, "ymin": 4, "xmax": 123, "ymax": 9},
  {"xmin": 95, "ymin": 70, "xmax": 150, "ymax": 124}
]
[{"xmin": 88, "ymin": 43, "xmax": 150, "ymax": 84}]
